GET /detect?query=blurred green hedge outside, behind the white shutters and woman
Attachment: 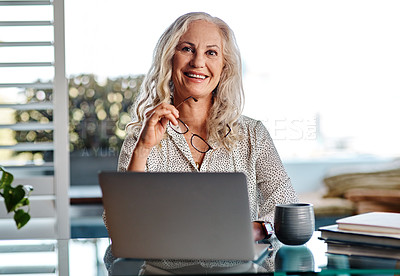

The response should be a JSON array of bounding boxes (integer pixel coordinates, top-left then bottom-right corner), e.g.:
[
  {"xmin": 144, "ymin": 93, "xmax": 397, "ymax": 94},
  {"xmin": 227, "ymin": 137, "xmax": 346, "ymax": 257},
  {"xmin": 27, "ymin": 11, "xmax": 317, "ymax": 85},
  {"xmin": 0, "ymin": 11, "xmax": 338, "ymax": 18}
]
[{"xmin": 12, "ymin": 74, "xmax": 144, "ymax": 162}]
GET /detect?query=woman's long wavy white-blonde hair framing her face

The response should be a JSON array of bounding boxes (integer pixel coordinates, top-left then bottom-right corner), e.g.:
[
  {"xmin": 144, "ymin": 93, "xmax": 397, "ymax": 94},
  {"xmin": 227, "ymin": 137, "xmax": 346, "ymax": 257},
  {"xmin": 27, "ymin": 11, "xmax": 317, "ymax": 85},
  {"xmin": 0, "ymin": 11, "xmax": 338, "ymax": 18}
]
[{"xmin": 128, "ymin": 12, "xmax": 244, "ymax": 149}]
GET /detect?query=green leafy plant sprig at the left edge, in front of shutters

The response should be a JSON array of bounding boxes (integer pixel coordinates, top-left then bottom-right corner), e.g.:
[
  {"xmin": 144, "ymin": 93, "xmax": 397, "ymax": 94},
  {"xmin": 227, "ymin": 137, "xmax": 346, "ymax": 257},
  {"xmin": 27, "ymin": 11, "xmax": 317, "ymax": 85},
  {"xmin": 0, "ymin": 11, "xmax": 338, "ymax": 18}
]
[{"xmin": 0, "ymin": 167, "xmax": 33, "ymax": 229}]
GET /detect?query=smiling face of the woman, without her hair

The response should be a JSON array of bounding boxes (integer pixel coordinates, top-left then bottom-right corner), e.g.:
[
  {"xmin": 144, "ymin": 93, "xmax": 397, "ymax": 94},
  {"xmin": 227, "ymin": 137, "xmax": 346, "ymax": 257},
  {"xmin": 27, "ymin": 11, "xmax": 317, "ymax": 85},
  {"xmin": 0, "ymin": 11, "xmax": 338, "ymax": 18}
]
[{"xmin": 172, "ymin": 20, "xmax": 224, "ymax": 101}]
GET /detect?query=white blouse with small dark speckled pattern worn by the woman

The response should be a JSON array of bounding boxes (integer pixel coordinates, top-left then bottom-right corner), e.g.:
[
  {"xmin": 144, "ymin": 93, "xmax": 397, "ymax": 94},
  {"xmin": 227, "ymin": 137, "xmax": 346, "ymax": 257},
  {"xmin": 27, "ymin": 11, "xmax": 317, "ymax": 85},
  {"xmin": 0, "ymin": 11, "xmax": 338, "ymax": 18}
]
[{"xmin": 118, "ymin": 116, "xmax": 297, "ymax": 222}]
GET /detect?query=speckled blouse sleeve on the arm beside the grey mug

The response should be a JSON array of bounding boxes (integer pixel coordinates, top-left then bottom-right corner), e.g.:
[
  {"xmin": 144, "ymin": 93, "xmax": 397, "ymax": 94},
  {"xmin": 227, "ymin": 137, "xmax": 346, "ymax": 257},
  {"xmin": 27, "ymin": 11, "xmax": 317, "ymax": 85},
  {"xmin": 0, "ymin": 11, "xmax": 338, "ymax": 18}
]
[{"xmin": 255, "ymin": 122, "xmax": 298, "ymax": 222}]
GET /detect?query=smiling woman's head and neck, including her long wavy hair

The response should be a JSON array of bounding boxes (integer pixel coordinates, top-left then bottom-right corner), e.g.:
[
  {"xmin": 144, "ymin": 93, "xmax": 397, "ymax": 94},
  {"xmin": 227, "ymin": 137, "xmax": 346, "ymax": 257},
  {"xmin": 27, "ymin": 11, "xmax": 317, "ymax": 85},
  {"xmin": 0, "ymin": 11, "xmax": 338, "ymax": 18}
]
[{"xmin": 126, "ymin": 13, "xmax": 243, "ymax": 164}]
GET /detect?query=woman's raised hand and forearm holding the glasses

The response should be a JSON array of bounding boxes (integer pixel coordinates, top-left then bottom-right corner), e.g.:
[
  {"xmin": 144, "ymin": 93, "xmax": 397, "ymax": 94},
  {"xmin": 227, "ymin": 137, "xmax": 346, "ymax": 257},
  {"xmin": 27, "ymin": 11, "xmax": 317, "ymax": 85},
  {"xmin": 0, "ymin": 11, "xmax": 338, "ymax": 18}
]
[{"xmin": 128, "ymin": 103, "xmax": 179, "ymax": 171}]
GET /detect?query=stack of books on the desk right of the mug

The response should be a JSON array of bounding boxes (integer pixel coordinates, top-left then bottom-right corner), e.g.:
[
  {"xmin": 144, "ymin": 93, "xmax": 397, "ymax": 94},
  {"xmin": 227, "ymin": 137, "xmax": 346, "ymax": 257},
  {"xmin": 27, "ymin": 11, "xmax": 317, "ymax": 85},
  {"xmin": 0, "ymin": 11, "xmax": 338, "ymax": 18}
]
[{"xmin": 318, "ymin": 212, "xmax": 400, "ymax": 260}]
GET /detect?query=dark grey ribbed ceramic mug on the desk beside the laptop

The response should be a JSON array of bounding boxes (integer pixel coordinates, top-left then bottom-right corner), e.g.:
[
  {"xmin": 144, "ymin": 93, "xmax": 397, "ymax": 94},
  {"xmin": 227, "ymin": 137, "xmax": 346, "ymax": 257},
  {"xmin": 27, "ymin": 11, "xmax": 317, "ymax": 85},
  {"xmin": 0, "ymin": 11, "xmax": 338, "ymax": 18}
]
[{"xmin": 274, "ymin": 203, "xmax": 315, "ymax": 245}]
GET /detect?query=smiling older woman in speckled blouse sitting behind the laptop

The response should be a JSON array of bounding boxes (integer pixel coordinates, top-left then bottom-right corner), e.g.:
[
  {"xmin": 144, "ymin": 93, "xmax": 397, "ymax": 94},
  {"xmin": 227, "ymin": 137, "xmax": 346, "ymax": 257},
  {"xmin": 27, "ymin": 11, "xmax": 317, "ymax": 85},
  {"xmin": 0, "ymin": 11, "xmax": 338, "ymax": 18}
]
[{"xmin": 104, "ymin": 10, "xmax": 297, "ymax": 272}]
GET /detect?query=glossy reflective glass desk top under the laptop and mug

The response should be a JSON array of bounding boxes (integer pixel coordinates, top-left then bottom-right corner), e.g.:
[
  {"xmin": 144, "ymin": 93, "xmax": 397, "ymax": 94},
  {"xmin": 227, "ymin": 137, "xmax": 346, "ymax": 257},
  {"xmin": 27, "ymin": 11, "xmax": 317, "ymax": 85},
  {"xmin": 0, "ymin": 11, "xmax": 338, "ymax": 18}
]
[{"xmin": 0, "ymin": 232, "xmax": 400, "ymax": 276}]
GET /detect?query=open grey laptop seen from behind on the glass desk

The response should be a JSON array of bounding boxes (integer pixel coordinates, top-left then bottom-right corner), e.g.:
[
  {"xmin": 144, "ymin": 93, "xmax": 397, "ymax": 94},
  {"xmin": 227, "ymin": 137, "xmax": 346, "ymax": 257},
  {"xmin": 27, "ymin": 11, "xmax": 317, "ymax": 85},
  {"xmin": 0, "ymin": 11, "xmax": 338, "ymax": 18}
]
[{"xmin": 99, "ymin": 172, "xmax": 269, "ymax": 261}]
